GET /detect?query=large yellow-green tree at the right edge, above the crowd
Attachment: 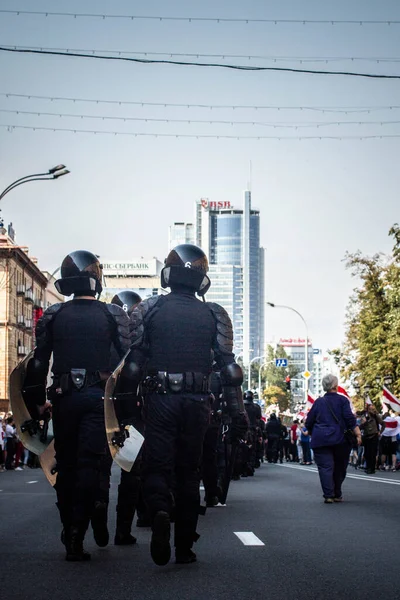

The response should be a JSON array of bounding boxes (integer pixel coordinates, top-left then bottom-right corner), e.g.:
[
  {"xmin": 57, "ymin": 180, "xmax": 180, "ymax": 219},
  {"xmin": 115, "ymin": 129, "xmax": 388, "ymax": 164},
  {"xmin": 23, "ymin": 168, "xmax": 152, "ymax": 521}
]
[{"xmin": 331, "ymin": 223, "xmax": 400, "ymax": 401}]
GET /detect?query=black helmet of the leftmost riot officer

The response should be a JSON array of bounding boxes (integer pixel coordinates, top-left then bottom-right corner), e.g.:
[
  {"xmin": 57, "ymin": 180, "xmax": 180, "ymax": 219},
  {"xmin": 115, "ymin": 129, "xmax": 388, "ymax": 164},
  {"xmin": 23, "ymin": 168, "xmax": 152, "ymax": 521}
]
[{"xmin": 54, "ymin": 250, "xmax": 103, "ymax": 296}]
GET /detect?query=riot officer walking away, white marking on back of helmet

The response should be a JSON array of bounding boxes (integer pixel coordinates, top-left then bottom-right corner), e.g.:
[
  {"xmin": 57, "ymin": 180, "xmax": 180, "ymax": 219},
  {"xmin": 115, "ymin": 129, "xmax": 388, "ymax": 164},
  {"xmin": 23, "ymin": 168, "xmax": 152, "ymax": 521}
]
[{"xmin": 130, "ymin": 244, "xmax": 247, "ymax": 565}]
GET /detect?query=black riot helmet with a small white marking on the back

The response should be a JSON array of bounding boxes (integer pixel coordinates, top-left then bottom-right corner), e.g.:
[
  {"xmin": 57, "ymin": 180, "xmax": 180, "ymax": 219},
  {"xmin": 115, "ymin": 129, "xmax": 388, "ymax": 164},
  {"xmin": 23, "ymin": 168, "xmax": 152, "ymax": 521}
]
[{"xmin": 161, "ymin": 244, "xmax": 211, "ymax": 296}]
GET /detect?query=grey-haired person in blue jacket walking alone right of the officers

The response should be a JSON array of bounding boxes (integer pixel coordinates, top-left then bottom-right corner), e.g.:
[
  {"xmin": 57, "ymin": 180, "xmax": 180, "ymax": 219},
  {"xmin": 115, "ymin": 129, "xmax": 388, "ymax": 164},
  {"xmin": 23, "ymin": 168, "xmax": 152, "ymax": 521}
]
[{"xmin": 306, "ymin": 375, "xmax": 361, "ymax": 504}]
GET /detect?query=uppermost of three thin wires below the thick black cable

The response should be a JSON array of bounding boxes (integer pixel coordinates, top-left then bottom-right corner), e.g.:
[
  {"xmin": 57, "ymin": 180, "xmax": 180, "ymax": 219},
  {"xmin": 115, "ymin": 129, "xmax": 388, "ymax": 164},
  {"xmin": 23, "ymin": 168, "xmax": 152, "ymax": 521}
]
[{"xmin": 0, "ymin": 92, "xmax": 400, "ymax": 114}]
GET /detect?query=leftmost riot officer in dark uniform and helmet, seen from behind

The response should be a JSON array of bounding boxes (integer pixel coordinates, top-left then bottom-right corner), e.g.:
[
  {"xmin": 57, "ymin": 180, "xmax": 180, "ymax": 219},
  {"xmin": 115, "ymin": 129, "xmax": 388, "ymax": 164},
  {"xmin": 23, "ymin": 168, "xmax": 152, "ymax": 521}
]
[{"xmin": 25, "ymin": 250, "xmax": 130, "ymax": 561}]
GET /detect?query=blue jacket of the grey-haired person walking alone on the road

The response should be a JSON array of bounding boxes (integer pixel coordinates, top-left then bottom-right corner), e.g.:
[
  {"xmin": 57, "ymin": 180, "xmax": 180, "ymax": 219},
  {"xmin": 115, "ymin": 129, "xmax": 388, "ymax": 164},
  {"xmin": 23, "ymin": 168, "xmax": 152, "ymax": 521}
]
[{"xmin": 306, "ymin": 392, "xmax": 357, "ymax": 448}]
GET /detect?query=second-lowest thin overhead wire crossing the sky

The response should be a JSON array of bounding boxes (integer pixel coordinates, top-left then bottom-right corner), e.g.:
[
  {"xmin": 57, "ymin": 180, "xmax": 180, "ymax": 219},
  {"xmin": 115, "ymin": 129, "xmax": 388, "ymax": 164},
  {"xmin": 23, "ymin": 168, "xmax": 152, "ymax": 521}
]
[{"xmin": 0, "ymin": 108, "xmax": 400, "ymax": 129}]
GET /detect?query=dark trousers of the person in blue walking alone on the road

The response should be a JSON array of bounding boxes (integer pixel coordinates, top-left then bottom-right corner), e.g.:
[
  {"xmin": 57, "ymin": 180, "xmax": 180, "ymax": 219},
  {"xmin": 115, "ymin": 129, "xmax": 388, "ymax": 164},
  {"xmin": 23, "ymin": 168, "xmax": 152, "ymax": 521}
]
[{"xmin": 313, "ymin": 442, "xmax": 351, "ymax": 498}]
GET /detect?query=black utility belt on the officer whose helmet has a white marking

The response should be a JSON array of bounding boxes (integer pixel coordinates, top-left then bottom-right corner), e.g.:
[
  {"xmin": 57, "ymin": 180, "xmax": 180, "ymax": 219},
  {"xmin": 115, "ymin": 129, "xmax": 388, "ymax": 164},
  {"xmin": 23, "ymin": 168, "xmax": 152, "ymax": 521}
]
[{"xmin": 142, "ymin": 371, "xmax": 210, "ymax": 394}]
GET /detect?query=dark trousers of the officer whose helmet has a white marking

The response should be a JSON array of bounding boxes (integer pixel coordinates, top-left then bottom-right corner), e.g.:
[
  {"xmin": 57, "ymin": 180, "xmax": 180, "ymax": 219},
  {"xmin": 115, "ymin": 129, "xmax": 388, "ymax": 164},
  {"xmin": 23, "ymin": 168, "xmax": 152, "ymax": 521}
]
[{"xmin": 143, "ymin": 393, "xmax": 210, "ymax": 549}]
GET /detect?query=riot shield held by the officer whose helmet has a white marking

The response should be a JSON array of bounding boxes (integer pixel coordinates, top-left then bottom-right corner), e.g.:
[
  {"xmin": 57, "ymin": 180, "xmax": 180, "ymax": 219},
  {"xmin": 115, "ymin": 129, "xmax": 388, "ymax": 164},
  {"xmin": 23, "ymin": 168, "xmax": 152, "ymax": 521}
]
[{"xmin": 104, "ymin": 353, "xmax": 144, "ymax": 471}]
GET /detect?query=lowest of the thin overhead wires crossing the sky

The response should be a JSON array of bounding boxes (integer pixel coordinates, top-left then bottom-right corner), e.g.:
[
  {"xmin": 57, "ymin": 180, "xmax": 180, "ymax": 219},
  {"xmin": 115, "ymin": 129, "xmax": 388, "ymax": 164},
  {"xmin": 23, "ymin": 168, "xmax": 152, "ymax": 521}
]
[{"xmin": 0, "ymin": 123, "xmax": 400, "ymax": 141}]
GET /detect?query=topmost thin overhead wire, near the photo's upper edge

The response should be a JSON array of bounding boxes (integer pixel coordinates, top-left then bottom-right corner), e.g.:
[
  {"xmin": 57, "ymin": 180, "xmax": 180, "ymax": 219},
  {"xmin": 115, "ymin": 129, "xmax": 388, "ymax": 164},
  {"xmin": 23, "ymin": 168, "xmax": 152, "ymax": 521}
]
[{"xmin": 0, "ymin": 10, "xmax": 400, "ymax": 25}]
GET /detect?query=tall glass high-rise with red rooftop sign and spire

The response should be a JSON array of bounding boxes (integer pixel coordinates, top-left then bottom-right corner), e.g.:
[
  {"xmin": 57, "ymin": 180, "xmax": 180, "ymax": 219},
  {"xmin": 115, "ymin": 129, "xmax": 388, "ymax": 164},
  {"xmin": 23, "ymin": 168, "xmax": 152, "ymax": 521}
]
[{"xmin": 195, "ymin": 191, "xmax": 264, "ymax": 365}]
